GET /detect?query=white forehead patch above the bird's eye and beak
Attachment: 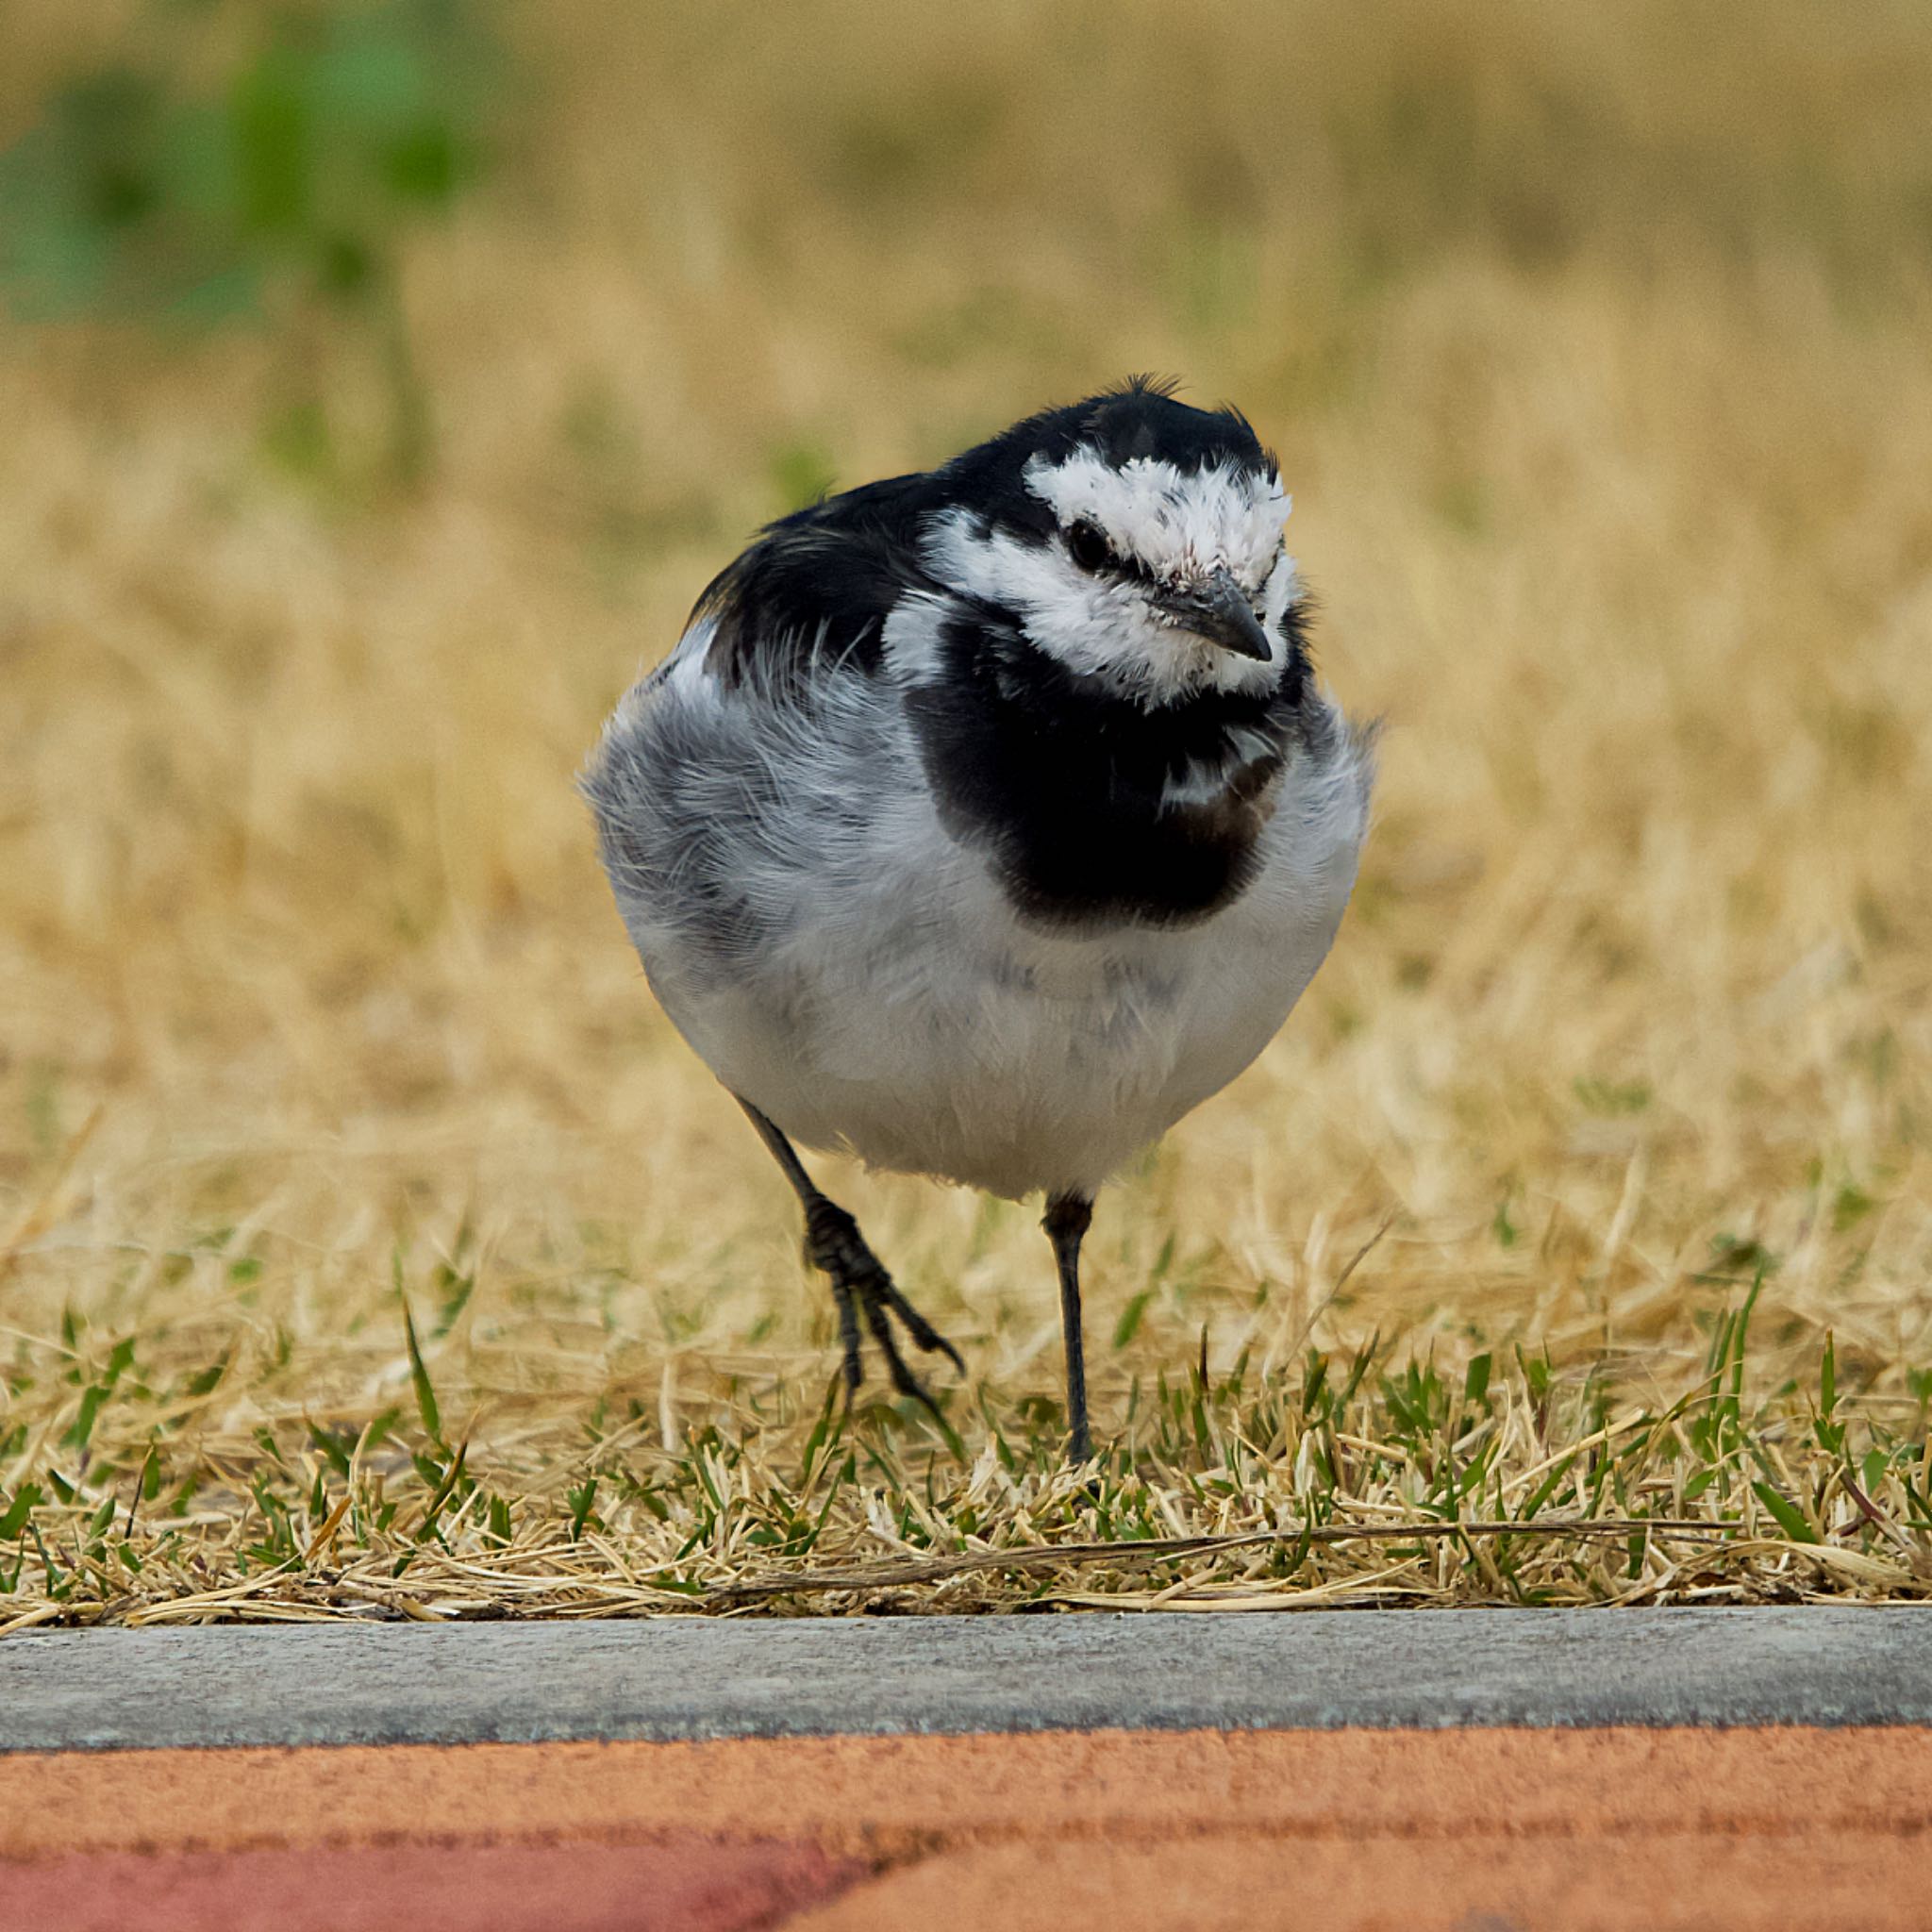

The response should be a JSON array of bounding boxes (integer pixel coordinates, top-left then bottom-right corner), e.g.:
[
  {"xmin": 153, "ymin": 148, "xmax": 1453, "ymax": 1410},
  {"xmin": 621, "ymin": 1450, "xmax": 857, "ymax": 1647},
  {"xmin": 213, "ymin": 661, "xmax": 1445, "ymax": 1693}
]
[{"xmin": 1024, "ymin": 450, "xmax": 1292, "ymax": 591}]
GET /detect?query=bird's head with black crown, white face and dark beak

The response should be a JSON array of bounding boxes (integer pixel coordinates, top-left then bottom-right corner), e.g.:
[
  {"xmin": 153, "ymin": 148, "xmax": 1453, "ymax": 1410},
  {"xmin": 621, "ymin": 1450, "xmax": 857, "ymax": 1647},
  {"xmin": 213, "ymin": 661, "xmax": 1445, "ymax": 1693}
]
[{"xmin": 925, "ymin": 380, "xmax": 1298, "ymax": 708}]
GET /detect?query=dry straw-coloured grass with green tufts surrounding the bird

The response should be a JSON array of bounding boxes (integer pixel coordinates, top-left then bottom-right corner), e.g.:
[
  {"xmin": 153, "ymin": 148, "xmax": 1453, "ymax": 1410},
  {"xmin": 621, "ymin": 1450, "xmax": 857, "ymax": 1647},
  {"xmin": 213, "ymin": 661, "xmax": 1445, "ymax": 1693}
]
[{"xmin": 0, "ymin": 0, "xmax": 1932, "ymax": 1626}]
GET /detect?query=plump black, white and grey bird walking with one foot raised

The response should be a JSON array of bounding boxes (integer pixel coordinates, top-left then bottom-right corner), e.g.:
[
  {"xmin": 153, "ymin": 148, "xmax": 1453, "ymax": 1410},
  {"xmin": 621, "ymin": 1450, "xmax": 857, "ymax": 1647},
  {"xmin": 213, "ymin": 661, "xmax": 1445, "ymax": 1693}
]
[{"xmin": 579, "ymin": 376, "xmax": 1374, "ymax": 1464}]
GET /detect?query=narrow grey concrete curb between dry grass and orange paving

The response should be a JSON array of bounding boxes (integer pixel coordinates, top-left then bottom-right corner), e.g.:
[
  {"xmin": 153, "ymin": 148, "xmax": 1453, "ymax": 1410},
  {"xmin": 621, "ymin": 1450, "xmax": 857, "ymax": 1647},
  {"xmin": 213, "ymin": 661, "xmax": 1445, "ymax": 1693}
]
[{"xmin": 0, "ymin": 1607, "xmax": 1932, "ymax": 1753}]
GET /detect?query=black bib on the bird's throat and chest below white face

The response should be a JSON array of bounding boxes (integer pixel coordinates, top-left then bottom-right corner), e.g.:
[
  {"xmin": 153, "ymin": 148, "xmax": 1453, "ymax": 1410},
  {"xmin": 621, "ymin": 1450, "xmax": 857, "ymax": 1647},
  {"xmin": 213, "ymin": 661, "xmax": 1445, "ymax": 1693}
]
[{"xmin": 907, "ymin": 614, "xmax": 1300, "ymax": 925}]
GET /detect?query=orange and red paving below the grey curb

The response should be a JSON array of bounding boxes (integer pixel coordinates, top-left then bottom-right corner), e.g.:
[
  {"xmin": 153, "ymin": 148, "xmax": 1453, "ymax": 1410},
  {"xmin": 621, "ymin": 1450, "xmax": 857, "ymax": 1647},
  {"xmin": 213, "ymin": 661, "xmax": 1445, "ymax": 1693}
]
[{"xmin": 0, "ymin": 1729, "xmax": 1932, "ymax": 1932}]
